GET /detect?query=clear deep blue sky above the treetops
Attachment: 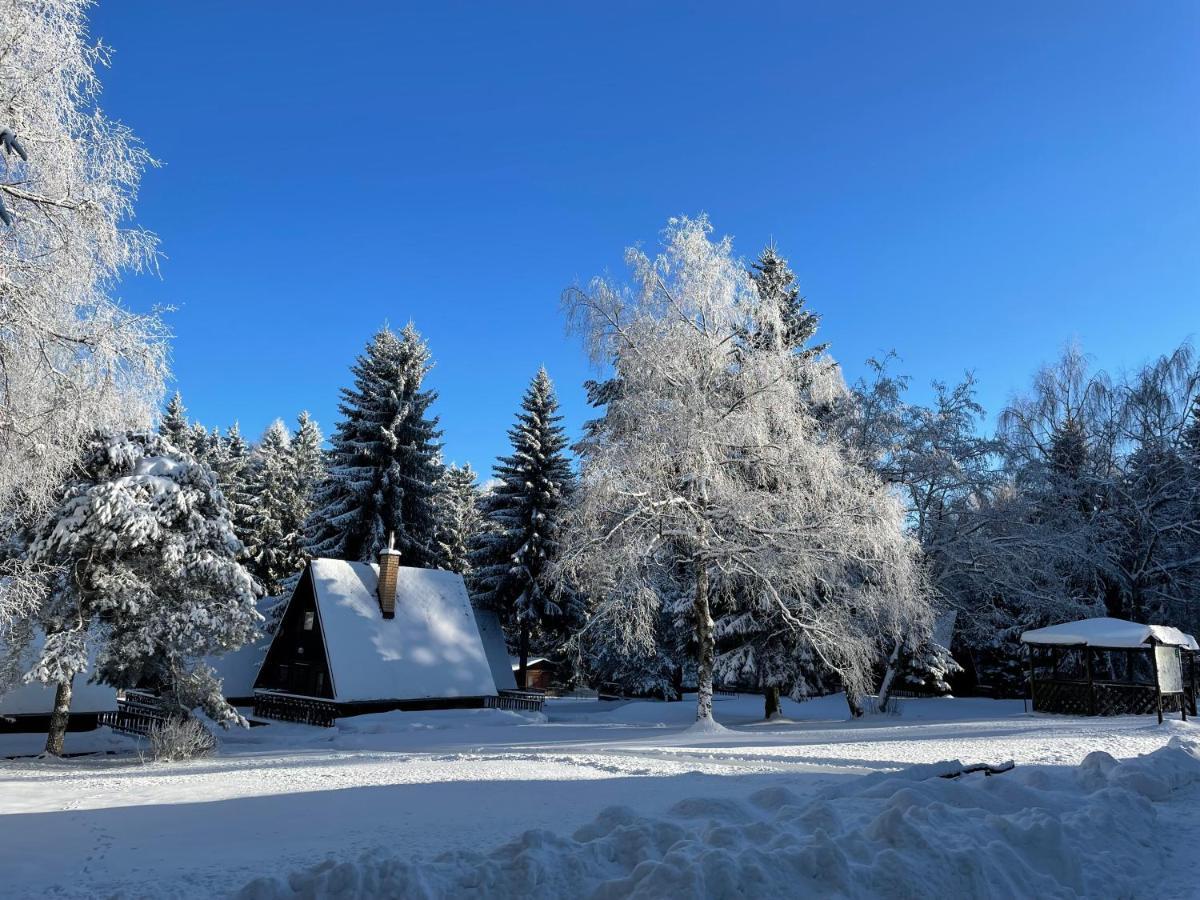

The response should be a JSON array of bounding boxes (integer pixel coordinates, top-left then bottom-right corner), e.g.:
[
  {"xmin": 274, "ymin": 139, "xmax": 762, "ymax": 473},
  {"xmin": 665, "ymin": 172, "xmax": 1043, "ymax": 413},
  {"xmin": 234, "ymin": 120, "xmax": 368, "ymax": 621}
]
[{"xmin": 92, "ymin": 0, "xmax": 1200, "ymax": 470}]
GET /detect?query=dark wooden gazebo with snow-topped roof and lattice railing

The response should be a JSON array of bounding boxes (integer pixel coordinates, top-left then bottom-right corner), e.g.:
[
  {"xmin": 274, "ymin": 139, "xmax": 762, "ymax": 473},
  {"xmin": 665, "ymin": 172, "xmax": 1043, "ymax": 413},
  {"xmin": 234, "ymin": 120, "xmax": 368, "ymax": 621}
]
[{"xmin": 1021, "ymin": 618, "xmax": 1200, "ymax": 721}]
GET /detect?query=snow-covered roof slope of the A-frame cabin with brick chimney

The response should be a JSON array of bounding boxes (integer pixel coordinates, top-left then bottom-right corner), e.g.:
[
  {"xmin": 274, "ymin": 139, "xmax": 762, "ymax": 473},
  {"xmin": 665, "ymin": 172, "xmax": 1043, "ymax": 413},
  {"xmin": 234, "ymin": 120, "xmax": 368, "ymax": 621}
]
[{"xmin": 311, "ymin": 559, "xmax": 496, "ymax": 702}]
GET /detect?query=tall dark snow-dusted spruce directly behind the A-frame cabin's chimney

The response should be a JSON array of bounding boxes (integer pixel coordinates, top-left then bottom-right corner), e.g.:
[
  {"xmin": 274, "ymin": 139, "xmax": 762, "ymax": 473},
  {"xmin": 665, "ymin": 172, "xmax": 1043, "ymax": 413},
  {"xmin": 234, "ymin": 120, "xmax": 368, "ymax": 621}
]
[{"xmin": 305, "ymin": 323, "xmax": 443, "ymax": 568}]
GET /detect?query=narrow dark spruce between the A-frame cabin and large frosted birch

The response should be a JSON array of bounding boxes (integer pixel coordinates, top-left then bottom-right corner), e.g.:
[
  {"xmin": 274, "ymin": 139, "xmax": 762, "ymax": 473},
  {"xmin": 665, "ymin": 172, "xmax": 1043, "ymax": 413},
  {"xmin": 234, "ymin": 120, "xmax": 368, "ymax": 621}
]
[{"xmin": 473, "ymin": 367, "xmax": 576, "ymax": 686}]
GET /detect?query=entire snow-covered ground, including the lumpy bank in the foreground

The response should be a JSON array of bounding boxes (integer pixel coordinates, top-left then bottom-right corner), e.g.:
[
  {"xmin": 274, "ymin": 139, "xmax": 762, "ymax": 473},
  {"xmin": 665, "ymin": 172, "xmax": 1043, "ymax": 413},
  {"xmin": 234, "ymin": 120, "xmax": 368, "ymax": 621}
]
[{"xmin": 0, "ymin": 696, "xmax": 1200, "ymax": 898}]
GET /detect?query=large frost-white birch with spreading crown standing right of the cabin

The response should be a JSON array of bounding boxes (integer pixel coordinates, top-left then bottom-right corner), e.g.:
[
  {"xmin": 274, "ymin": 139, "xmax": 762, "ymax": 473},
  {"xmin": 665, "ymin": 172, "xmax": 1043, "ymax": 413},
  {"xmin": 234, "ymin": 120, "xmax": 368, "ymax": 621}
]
[{"xmin": 559, "ymin": 218, "xmax": 930, "ymax": 722}]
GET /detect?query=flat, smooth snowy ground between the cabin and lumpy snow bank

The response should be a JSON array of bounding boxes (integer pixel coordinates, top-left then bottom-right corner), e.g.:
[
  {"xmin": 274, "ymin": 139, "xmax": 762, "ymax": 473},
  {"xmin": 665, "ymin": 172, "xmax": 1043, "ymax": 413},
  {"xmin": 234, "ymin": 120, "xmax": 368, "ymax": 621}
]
[{"xmin": 0, "ymin": 698, "xmax": 1196, "ymax": 898}]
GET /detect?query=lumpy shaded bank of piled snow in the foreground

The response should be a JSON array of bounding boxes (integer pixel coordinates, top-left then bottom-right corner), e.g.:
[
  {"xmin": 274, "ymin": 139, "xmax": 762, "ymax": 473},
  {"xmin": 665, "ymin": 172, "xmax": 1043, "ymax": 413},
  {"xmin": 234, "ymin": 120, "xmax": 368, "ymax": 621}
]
[{"xmin": 231, "ymin": 736, "xmax": 1200, "ymax": 900}]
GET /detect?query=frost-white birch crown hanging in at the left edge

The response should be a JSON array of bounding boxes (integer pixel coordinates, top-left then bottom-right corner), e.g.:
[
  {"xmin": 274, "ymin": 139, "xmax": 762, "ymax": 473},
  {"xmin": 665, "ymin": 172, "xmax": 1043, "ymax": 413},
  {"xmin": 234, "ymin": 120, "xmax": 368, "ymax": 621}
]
[{"xmin": 0, "ymin": 0, "xmax": 167, "ymax": 520}]
